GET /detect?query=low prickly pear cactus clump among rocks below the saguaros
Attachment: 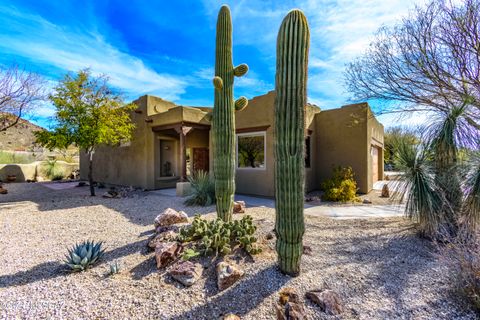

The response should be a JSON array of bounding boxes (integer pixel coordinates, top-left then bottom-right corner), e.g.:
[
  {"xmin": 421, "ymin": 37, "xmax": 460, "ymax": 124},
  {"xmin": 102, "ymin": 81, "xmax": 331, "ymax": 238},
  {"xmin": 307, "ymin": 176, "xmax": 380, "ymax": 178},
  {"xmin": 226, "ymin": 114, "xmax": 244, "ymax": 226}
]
[{"xmin": 177, "ymin": 215, "xmax": 261, "ymax": 259}]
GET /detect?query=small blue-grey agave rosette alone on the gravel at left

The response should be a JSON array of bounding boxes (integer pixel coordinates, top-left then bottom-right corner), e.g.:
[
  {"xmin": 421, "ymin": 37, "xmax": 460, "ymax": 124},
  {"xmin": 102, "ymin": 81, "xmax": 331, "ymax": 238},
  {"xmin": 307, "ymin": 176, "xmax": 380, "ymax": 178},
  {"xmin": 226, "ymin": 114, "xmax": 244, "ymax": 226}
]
[{"xmin": 66, "ymin": 240, "xmax": 104, "ymax": 271}]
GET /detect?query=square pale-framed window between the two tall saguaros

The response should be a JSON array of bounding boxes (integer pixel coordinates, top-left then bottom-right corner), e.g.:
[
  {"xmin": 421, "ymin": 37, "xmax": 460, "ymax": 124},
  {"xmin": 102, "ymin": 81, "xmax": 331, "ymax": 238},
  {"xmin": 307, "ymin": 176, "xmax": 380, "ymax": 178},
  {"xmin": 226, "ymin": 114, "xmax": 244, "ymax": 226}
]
[{"xmin": 237, "ymin": 132, "xmax": 266, "ymax": 170}]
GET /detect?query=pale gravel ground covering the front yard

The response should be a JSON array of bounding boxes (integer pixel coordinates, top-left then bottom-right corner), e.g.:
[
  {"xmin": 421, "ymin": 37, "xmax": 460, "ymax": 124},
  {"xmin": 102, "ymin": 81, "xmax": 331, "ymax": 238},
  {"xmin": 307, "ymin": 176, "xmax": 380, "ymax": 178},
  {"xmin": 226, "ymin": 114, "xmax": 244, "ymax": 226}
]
[{"xmin": 0, "ymin": 184, "xmax": 475, "ymax": 319}]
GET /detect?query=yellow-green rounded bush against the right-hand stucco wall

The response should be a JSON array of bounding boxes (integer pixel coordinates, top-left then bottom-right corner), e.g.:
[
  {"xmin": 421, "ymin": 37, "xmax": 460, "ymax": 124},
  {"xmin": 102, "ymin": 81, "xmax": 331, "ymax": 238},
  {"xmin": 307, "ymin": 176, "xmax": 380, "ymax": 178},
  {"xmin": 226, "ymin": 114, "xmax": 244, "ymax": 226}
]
[{"xmin": 322, "ymin": 166, "xmax": 357, "ymax": 202}]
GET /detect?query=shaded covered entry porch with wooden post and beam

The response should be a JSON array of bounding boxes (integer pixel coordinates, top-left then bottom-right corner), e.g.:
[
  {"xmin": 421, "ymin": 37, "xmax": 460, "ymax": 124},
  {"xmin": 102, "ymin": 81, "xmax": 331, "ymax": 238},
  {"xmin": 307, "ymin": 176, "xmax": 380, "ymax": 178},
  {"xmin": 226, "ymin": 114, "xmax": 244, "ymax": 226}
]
[{"xmin": 152, "ymin": 122, "xmax": 210, "ymax": 189}]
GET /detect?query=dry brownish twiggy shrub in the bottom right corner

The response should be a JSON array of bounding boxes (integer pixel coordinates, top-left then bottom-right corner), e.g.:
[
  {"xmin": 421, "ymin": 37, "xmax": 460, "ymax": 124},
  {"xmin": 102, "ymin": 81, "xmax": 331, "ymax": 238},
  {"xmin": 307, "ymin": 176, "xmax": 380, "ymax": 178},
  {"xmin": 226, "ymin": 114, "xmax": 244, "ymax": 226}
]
[{"xmin": 440, "ymin": 239, "xmax": 480, "ymax": 313}]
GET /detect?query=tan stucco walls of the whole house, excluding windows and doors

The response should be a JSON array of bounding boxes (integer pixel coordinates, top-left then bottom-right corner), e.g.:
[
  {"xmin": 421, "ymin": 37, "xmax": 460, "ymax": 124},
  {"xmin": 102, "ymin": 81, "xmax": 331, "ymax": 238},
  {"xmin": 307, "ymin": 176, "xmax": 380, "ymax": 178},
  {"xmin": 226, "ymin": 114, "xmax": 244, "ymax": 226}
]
[{"xmin": 80, "ymin": 91, "xmax": 383, "ymax": 197}]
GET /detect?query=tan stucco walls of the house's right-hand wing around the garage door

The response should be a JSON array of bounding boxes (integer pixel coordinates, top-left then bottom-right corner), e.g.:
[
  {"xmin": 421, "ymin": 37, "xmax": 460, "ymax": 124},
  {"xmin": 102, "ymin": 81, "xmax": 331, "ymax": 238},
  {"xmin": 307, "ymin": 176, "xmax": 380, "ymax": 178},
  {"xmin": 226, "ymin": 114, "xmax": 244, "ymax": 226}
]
[{"xmin": 315, "ymin": 103, "xmax": 383, "ymax": 193}]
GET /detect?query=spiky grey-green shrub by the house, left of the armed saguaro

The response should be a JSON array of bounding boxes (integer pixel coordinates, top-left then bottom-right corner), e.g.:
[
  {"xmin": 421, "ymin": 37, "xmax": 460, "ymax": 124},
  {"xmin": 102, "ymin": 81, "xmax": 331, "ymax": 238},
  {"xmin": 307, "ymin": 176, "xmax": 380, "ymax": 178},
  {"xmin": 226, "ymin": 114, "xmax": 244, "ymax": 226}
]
[{"xmin": 185, "ymin": 170, "xmax": 215, "ymax": 206}]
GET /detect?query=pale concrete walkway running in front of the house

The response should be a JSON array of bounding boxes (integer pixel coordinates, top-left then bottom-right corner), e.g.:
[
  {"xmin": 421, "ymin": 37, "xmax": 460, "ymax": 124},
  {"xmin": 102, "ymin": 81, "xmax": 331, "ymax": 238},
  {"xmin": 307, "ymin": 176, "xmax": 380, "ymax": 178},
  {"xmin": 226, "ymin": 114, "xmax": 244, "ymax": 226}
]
[{"xmin": 152, "ymin": 189, "xmax": 405, "ymax": 219}]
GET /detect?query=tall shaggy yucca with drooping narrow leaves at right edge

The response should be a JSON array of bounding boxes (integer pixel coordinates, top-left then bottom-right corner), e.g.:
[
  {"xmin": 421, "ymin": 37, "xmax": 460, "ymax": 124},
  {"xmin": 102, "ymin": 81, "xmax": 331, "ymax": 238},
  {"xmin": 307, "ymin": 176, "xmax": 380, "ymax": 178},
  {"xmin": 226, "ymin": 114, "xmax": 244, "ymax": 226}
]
[{"xmin": 395, "ymin": 101, "xmax": 480, "ymax": 241}]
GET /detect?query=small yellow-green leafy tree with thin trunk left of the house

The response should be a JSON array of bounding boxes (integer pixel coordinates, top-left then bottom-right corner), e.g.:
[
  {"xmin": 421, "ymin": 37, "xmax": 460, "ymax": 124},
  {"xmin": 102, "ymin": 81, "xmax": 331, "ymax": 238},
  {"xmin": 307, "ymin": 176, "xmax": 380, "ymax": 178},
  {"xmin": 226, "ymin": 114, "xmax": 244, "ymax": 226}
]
[{"xmin": 35, "ymin": 70, "xmax": 136, "ymax": 196}]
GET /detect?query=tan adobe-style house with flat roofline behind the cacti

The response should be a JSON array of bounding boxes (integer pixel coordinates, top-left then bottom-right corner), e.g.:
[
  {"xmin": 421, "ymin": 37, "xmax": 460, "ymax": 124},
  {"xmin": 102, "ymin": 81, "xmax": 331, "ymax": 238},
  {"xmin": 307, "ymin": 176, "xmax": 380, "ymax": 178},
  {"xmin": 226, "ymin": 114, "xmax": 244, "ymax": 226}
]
[{"xmin": 80, "ymin": 91, "xmax": 383, "ymax": 197}]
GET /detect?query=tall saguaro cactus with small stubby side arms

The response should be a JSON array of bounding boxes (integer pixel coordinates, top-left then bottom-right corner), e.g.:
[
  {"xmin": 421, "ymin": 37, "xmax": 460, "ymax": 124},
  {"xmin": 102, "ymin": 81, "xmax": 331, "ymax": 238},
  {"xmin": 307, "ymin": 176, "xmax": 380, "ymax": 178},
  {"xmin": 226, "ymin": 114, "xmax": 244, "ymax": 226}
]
[{"xmin": 212, "ymin": 5, "xmax": 248, "ymax": 221}]
